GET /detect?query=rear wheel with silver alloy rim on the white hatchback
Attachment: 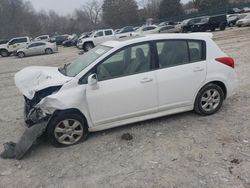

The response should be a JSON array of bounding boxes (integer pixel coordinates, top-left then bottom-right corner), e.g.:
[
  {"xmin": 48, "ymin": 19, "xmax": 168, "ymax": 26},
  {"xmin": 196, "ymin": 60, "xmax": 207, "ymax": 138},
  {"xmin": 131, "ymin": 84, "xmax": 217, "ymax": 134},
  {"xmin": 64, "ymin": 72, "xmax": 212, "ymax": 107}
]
[{"xmin": 194, "ymin": 83, "xmax": 225, "ymax": 116}]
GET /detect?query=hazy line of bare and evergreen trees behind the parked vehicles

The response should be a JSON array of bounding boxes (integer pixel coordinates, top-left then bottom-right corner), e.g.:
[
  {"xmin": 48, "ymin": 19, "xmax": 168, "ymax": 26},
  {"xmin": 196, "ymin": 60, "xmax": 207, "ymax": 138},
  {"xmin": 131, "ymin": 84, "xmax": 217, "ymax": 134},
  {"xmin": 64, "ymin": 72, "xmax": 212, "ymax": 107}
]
[{"xmin": 0, "ymin": 0, "xmax": 246, "ymax": 39}]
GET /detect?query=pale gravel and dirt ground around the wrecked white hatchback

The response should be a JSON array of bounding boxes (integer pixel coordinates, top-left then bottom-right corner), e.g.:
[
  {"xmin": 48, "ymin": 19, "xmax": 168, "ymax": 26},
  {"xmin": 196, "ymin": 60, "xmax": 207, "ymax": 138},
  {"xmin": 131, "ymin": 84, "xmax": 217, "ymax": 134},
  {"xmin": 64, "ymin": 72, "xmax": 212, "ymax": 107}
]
[{"xmin": 0, "ymin": 28, "xmax": 250, "ymax": 188}]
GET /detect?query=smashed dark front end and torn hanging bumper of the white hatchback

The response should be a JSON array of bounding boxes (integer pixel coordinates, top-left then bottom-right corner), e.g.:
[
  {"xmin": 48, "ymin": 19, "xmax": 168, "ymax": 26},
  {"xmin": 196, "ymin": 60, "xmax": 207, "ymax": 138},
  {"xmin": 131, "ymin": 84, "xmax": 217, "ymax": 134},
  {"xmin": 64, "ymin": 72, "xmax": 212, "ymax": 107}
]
[{"xmin": 0, "ymin": 86, "xmax": 62, "ymax": 160}]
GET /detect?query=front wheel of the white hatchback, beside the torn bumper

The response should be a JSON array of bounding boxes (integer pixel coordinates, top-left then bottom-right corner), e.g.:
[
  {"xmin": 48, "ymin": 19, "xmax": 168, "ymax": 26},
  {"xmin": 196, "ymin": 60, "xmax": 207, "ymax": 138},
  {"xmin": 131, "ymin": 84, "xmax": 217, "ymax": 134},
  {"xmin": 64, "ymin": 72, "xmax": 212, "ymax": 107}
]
[{"xmin": 47, "ymin": 112, "xmax": 88, "ymax": 147}]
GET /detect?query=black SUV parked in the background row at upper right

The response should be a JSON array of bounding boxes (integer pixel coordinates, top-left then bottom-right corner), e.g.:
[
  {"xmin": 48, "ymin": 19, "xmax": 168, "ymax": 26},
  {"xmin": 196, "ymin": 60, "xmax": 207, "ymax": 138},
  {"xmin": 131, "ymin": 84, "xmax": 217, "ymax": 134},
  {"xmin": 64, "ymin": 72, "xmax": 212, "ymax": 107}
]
[{"xmin": 191, "ymin": 14, "xmax": 227, "ymax": 32}]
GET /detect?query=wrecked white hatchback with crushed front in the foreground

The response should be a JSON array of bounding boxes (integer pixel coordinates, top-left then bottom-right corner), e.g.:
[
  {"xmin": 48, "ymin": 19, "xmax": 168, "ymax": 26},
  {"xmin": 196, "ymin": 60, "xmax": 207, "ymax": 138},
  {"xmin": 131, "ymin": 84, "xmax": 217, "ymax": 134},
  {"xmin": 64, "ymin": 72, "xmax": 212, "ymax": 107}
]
[{"xmin": 15, "ymin": 33, "xmax": 238, "ymax": 146}]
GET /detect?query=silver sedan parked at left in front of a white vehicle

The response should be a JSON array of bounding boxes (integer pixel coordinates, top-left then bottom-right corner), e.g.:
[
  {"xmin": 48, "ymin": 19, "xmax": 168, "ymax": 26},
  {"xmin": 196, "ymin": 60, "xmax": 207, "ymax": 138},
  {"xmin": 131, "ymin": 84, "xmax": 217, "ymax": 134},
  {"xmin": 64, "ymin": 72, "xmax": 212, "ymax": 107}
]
[{"xmin": 16, "ymin": 41, "xmax": 58, "ymax": 58}]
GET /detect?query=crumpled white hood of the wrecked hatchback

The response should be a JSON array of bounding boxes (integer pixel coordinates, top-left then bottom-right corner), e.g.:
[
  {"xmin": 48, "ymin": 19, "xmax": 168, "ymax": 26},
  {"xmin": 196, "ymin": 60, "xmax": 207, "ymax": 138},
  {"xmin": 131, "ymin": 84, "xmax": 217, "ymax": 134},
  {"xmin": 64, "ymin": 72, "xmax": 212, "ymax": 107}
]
[{"xmin": 15, "ymin": 66, "xmax": 72, "ymax": 99}]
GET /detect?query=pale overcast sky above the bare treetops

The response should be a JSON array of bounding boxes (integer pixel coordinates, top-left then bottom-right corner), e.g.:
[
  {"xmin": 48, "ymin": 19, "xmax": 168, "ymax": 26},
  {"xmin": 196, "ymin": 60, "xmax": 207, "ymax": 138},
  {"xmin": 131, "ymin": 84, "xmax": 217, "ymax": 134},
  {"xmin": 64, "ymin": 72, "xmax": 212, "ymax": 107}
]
[{"xmin": 26, "ymin": 0, "xmax": 188, "ymax": 15}]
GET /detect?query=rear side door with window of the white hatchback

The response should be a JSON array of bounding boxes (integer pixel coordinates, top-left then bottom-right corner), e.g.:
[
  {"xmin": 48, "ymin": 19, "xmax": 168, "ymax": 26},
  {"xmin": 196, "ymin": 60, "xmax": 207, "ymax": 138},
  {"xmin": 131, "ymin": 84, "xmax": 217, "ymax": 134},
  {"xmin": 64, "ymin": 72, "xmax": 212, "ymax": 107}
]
[{"xmin": 156, "ymin": 40, "xmax": 206, "ymax": 111}]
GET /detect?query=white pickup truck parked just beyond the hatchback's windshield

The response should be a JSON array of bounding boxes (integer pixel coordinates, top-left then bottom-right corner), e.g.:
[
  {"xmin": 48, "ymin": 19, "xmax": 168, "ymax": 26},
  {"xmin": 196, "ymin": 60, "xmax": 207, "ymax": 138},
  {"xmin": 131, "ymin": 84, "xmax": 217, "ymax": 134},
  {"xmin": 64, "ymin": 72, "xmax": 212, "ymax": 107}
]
[{"xmin": 77, "ymin": 29, "xmax": 115, "ymax": 52}]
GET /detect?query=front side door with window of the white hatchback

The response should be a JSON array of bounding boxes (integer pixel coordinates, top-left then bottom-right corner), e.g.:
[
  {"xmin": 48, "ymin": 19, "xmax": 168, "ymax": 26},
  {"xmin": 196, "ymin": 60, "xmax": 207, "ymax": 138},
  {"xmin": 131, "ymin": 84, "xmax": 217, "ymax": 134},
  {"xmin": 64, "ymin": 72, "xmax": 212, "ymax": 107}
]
[{"xmin": 87, "ymin": 43, "xmax": 157, "ymax": 125}]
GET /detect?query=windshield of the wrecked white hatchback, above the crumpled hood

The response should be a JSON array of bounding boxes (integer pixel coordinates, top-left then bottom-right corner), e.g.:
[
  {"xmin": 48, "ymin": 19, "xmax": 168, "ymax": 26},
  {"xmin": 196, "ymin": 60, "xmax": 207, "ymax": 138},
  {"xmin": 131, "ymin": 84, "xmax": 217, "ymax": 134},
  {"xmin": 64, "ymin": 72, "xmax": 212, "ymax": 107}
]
[{"xmin": 59, "ymin": 46, "xmax": 111, "ymax": 77}]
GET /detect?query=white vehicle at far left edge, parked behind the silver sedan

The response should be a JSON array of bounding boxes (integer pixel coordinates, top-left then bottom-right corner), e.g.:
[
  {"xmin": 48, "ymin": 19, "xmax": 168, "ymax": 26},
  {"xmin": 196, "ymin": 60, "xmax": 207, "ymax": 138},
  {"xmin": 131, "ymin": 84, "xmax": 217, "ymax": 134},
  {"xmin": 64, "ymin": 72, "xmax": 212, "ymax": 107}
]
[{"xmin": 0, "ymin": 37, "xmax": 31, "ymax": 57}]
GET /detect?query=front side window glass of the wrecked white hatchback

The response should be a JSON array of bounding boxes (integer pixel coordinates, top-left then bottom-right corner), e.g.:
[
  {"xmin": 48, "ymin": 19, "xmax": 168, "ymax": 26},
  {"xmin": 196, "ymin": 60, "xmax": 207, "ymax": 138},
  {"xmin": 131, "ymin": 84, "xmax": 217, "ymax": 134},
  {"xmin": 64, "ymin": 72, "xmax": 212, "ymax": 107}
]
[{"xmin": 96, "ymin": 44, "xmax": 151, "ymax": 81}]
